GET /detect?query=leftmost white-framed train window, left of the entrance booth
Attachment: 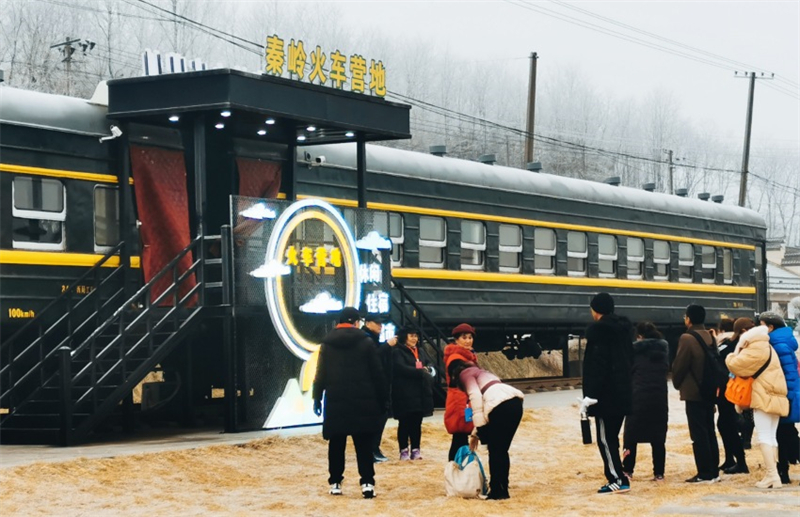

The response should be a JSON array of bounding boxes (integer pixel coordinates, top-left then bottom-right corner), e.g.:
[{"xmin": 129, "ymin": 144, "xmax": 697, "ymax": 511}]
[{"xmin": 11, "ymin": 176, "xmax": 67, "ymax": 250}]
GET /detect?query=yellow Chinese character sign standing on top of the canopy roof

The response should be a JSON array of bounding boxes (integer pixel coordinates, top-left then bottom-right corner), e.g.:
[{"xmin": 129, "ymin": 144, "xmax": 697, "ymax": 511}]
[{"xmin": 264, "ymin": 34, "xmax": 386, "ymax": 97}]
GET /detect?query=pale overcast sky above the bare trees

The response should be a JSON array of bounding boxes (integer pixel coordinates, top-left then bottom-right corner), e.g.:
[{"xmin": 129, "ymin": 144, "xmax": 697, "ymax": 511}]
[{"xmin": 336, "ymin": 0, "xmax": 800, "ymax": 150}]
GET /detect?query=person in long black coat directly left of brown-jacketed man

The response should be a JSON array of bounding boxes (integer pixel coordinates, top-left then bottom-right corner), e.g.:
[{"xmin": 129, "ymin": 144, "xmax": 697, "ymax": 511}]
[{"xmin": 622, "ymin": 321, "xmax": 669, "ymax": 481}]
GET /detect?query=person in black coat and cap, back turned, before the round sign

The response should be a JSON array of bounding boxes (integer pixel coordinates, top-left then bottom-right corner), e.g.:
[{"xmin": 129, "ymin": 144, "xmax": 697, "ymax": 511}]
[{"xmin": 313, "ymin": 307, "xmax": 388, "ymax": 499}]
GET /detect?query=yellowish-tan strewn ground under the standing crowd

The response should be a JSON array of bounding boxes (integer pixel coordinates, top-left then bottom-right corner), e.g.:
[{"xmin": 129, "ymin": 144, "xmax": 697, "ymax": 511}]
[{"xmin": 0, "ymin": 392, "xmax": 796, "ymax": 517}]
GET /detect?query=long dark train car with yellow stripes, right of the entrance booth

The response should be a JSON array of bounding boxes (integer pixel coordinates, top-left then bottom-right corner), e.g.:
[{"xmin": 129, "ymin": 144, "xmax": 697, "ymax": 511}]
[{"xmin": 298, "ymin": 146, "xmax": 766, "ymax": 349}]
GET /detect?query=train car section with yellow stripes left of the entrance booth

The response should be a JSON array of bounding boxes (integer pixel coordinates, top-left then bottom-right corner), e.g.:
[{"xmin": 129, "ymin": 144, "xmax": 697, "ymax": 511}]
[{"xmin": 0, "ymin": 88, "xmax": 138, "ymax": 336}]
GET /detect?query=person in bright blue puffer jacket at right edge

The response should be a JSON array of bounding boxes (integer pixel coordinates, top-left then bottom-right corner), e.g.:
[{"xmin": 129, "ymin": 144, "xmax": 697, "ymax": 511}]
[{"xmin": 758, "ymin": 312, "xmax": 800, "ymax": 484}]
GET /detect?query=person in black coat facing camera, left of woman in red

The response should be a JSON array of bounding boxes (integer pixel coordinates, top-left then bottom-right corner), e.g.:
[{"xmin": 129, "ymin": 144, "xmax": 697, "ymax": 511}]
[{"xmin": 392, "ymin": 327, "xmax": 433, "ymax": 460}]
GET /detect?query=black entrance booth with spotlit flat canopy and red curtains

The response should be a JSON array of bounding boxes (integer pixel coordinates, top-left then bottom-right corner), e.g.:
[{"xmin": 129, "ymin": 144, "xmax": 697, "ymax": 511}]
[{"xmin": 103, "ymin": 69, "xmax": 411, "ymax": 432}]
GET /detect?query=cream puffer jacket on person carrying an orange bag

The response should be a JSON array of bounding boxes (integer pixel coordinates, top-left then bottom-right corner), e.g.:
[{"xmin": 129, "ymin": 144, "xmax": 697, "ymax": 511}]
[{"xmin": 725, "ymin": 325, "xmax": 789, "ymax": 416}]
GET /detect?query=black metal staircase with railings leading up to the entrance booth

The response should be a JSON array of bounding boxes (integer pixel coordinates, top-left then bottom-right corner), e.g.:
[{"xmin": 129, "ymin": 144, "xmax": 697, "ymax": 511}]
[{"xmin": 0, "ymin": 237, "xmax": 219, "ymax": 445}]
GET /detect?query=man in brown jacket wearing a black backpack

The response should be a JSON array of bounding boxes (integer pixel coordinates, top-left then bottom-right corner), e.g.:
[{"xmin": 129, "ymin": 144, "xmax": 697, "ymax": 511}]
[{"xmin": 672, "ymin": 305, "xmax": 719, "ymax": 483}]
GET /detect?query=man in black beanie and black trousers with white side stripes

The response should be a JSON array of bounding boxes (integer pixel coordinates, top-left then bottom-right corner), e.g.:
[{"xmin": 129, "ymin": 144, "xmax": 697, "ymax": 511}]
[{"xmin": 583, "ymin": 293, "xmax": 633, "ymax": 494}]
